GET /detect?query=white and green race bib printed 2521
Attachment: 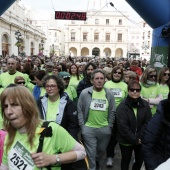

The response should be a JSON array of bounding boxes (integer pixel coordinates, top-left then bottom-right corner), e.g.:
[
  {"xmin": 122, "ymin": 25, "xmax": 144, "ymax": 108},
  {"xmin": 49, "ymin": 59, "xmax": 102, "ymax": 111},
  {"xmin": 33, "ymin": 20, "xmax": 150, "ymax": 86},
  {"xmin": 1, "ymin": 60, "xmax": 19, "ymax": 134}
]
[{"xmin": 8, "ymin": 141, "xmax": 34, "ymax": 170}]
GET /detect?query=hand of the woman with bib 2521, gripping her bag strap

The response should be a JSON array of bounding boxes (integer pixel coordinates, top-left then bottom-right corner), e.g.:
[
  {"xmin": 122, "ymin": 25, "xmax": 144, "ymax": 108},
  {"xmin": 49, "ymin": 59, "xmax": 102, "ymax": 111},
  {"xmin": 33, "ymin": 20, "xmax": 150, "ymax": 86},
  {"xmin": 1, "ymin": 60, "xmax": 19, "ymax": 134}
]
[{"xmin": 31, "ymin": 152, "xmax": 56, "ymax": 168}]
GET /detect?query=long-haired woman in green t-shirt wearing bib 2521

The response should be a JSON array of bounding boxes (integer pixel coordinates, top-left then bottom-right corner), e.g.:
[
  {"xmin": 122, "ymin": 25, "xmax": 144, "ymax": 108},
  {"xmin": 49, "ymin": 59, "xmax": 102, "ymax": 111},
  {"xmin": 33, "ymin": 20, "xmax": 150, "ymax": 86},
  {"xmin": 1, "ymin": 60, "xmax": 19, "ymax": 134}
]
[{"xmin": 0, "ymin": 85, "xmax": 86, "ymax": 170}]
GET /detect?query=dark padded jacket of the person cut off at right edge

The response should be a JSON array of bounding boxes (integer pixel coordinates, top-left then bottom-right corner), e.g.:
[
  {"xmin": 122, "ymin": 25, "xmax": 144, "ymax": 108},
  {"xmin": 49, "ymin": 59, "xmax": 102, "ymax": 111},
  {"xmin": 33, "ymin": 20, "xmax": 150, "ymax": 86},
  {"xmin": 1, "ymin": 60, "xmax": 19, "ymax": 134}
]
[{"xmin": 142, "ymin": 99, "xmax": 170, "ymax": 170}]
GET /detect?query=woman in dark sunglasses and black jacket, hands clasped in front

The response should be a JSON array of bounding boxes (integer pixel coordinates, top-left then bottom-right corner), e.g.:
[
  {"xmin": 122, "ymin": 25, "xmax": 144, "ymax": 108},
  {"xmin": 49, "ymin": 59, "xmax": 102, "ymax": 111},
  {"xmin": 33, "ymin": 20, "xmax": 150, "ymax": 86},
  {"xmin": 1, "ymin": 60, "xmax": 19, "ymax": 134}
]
[{"xmin": 116, "ymin": 81, "xmax": 152, "ymax": 170}]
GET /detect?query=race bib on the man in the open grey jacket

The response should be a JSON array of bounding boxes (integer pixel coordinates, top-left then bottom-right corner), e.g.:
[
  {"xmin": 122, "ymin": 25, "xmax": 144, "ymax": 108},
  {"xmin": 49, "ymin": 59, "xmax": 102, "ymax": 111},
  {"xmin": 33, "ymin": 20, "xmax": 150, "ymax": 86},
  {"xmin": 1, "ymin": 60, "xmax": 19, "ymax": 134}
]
[{"xmin": 90, "ymin": 99, "xmax": 106, "ymax": 111}]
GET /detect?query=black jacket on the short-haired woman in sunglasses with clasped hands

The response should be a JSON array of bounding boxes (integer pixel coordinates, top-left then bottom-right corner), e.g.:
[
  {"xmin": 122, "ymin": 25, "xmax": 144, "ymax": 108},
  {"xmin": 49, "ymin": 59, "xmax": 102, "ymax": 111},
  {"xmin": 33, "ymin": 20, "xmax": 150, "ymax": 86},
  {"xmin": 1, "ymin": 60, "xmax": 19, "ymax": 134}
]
[{"xmin": 116, "ymin": 96, "xmax": 152, "ymax": 145}]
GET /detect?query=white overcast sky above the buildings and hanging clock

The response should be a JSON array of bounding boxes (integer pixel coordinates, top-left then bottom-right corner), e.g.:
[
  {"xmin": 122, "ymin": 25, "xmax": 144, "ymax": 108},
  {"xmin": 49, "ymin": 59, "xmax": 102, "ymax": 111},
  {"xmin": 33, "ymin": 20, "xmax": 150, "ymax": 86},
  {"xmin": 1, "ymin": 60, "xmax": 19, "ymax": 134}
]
[{"xmin": 20, "ymin": 0, "xmax": 140, "ymax": 21}]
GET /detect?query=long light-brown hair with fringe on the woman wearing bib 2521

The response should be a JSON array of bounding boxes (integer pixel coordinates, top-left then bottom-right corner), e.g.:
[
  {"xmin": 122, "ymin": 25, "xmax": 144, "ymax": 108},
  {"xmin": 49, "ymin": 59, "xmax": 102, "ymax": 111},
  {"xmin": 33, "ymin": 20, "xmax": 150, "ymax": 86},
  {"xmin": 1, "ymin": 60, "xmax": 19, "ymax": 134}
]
[{"xmin": 0, "ymin": 85, "xmax": 40, "ymax": 152}]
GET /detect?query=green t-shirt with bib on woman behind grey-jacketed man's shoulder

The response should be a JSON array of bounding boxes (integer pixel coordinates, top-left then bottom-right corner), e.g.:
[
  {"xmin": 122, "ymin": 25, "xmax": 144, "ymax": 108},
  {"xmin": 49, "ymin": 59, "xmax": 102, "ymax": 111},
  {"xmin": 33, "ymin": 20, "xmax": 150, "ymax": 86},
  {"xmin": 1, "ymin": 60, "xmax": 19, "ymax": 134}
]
[{"xmin": 104, "ymin": 80, "xmax": 128, "ymax": 107}]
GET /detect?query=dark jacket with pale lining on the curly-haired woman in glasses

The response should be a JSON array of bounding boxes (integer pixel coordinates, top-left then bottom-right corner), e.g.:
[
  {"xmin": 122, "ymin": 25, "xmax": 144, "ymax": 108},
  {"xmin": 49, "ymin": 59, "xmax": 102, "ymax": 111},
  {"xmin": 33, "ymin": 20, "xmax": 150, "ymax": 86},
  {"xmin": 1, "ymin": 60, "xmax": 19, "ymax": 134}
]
[{"xmin": 37, "ymin": 92, "xmax": 79, "ymax": 140}]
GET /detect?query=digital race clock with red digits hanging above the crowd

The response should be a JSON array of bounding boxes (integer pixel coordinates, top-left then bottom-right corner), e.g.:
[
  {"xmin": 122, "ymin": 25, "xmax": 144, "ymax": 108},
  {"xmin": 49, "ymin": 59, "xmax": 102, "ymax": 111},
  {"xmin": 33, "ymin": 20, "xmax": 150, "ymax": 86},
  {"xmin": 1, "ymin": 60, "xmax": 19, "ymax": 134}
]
[{"xmin": 55, "ymin": 11, "xmax": 86, "ymax": 21}]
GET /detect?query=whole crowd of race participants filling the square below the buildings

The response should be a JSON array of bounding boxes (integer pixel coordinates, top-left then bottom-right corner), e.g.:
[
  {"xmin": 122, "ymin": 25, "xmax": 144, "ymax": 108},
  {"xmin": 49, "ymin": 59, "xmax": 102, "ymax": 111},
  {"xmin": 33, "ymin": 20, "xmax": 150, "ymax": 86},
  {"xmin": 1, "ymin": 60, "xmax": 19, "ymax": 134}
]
[{"xmin": 0, "ymin": 56, "xmax": 170, "ymax": 170}]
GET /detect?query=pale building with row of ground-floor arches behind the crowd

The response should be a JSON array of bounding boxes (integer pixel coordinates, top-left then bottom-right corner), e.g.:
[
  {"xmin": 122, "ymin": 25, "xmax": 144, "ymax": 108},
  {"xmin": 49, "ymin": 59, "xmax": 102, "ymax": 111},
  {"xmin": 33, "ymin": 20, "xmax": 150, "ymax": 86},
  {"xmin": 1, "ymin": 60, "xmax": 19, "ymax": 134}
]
[{"xmin": 65, "ymin": 10, "xmax": 128, "ymax": 57}]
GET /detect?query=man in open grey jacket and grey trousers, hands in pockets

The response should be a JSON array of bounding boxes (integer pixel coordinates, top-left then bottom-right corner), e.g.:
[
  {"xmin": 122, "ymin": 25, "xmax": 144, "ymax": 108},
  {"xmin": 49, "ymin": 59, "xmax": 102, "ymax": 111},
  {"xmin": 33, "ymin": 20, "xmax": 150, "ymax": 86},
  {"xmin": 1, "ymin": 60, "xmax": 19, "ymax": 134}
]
[{"xmin": 77, "ymin": 70, "xmax": 116, "ymax": 170}]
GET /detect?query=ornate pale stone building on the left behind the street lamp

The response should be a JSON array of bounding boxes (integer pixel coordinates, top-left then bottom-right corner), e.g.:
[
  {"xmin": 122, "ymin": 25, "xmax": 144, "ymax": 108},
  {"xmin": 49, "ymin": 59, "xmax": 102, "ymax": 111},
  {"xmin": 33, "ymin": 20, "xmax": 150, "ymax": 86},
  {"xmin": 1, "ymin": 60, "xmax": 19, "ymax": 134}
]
[{"xmin": 0, "ymin": 1, "xmax": 46, "ymax": 57}]
